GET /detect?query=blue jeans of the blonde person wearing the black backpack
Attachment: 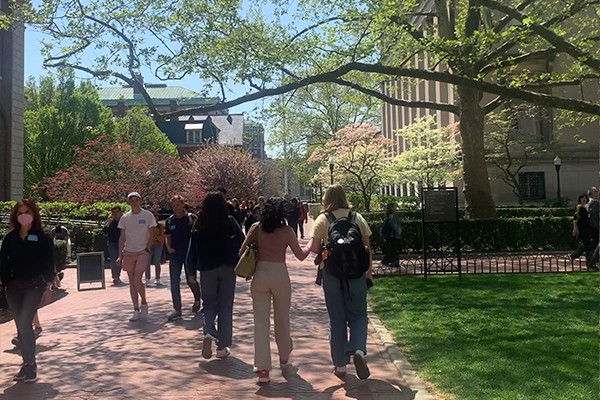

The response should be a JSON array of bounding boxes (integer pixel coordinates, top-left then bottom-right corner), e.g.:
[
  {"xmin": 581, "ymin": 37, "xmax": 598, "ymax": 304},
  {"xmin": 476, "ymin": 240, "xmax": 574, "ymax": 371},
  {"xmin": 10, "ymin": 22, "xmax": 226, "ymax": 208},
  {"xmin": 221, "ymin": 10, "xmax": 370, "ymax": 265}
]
[{"xmin": 323, "ymin": 270, "xmax": 367, "ymax": 367}]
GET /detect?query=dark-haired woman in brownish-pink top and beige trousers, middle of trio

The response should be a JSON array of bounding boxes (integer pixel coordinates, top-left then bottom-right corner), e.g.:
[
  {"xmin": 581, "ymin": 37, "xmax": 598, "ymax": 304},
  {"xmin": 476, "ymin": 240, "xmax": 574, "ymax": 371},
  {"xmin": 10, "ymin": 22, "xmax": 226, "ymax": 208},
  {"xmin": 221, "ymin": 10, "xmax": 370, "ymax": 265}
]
[{"xmin": 240, "ymin": 198, "xmax": 310, "ymax": 384}]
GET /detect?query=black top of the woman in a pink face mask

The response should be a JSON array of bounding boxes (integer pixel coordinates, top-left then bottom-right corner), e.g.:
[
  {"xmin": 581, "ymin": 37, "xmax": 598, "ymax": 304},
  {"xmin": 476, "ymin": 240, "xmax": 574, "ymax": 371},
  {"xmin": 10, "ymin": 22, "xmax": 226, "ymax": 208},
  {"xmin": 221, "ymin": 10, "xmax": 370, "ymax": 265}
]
[{"xmin": 0, "ymin": 230, "xmax": 56, "ymax": 286}]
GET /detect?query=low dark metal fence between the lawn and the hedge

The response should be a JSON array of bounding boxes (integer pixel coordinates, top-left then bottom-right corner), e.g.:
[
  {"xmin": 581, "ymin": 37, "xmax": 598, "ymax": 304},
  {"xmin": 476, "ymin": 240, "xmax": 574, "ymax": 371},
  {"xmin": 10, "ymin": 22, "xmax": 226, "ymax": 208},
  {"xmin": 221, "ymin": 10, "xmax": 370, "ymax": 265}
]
[{"xmin": 373, "ymin": 252, "xmax": 588, "ymax": 276}]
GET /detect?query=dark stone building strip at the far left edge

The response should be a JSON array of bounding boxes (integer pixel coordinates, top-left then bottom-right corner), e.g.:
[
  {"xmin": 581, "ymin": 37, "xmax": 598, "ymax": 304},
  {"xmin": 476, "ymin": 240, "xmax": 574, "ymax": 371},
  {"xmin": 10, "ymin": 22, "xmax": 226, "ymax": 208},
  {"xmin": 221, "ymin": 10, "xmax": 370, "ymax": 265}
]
[{"xmin": 0, "ymin": 0, "xmax": 25, "ymax": 200}]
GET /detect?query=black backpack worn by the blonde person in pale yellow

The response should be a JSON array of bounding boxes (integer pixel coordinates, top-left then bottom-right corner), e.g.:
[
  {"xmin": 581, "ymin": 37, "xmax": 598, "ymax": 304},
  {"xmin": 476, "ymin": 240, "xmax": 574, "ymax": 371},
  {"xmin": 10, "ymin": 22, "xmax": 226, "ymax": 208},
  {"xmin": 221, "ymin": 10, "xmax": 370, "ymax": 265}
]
[{"xmin": 324, "ymin": 211, "xmax": 369, "ymax": 280}]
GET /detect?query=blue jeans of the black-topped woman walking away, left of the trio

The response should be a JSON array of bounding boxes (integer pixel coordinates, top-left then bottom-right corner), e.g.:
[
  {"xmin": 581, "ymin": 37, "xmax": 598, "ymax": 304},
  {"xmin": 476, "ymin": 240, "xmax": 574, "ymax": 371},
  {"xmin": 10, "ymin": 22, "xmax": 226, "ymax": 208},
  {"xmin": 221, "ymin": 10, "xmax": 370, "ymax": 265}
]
[{"xmin": 200, "ymin": 265, "xmax": 236, "ymax": 349}]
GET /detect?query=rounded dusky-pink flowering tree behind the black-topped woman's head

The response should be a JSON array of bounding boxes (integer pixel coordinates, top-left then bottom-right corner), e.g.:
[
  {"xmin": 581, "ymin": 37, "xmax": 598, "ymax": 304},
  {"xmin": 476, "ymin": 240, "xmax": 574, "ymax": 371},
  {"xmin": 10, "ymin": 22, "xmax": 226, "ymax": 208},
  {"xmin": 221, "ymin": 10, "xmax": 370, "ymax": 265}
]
[{"xmin": 184, "ymin": 145, "xmax": 261, "ymax": 204}]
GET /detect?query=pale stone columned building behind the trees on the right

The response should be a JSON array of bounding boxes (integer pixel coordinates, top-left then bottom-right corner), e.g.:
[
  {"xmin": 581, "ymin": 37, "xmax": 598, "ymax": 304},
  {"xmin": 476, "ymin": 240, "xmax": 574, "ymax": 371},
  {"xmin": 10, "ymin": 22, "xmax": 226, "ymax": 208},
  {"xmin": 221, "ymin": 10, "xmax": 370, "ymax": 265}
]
[{"xmin": 381, "ymin": 5, "xmax": 599, "ymax": 206}]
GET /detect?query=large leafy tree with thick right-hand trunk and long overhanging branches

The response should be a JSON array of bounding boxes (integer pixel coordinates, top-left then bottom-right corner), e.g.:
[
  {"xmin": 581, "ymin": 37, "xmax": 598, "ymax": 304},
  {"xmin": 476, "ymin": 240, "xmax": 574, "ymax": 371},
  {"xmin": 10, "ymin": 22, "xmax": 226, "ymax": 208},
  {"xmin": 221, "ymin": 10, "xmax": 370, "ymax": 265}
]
[{"xmin": 14, "ymin": 0, "xmax": 600, "ymax": 217}]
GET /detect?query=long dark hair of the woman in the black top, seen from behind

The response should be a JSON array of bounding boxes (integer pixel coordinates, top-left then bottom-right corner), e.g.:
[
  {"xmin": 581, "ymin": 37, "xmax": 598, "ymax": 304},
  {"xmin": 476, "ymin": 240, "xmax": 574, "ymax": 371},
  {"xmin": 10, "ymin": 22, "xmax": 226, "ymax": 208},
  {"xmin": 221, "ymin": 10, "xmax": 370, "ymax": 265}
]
[{"xmin": 196, "ymin": 192, "xmax": 234, "ymax": 238}]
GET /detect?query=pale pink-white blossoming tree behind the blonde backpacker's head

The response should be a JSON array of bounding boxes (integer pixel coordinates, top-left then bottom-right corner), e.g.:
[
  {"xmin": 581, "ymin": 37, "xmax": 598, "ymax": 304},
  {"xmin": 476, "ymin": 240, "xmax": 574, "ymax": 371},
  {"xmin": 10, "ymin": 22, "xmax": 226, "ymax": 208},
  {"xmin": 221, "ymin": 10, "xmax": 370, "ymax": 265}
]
[{"xmin": 308, "ymin": 124, "xmax": 391, "ymax": 211}]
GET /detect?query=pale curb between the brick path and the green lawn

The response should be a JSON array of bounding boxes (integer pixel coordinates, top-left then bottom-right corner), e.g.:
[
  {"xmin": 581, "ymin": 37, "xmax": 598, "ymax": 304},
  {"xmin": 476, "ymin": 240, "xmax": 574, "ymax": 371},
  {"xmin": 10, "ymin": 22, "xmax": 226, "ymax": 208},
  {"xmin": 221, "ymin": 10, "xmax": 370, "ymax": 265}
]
[{"xmin": 367, "ymin": 307, "xmax": 440, "ymax": 400}]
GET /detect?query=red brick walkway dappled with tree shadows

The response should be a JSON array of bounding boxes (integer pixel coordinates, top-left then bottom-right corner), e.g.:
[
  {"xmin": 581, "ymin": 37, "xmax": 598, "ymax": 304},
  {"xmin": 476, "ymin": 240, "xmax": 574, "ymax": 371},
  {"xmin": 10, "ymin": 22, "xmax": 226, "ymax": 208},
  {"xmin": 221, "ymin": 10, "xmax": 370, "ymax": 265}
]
[{"xmin": 0, "ymin": 239, "xmax": 432, "ymax": 400}]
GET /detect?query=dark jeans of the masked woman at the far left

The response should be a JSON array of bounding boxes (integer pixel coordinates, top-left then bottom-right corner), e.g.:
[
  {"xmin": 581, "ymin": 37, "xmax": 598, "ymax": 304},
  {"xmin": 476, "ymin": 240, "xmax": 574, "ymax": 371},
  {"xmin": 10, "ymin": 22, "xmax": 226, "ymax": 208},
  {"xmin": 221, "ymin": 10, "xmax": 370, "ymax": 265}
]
[{"xmin": 6, "ymin": 282, "xmax": 46, "ymax": 363}]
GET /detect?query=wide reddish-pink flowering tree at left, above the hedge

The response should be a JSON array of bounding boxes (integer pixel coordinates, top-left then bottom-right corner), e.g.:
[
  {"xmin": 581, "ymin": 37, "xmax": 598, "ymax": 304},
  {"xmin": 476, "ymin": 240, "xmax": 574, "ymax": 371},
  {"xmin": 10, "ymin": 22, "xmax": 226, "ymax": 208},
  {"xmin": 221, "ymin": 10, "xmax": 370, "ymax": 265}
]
[{"xmin": 45, "ymin": 136, "xmax": 188, "ymax": 208}]
